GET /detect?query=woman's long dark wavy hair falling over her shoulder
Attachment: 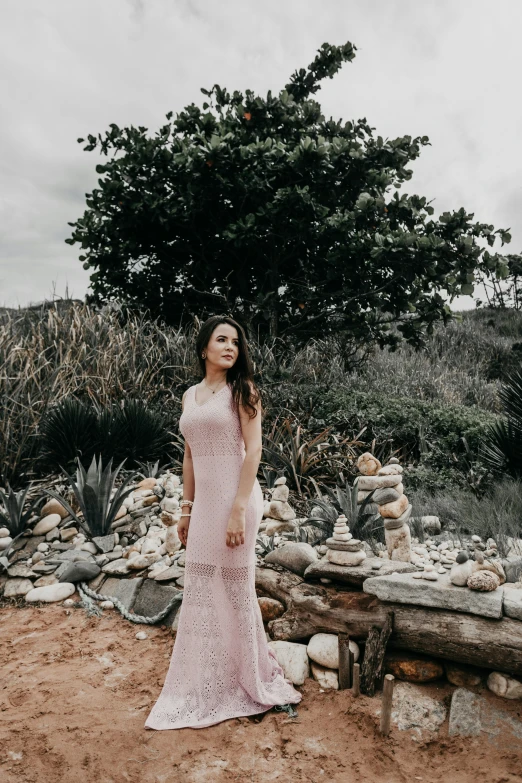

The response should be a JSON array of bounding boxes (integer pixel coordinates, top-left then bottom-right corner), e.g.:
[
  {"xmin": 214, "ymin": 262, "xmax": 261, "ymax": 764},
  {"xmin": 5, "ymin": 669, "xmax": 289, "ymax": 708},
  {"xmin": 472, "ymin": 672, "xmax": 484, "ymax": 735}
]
[{"xmin": 196, "ymin": 315, "xmax": 263, "ymax": 419}]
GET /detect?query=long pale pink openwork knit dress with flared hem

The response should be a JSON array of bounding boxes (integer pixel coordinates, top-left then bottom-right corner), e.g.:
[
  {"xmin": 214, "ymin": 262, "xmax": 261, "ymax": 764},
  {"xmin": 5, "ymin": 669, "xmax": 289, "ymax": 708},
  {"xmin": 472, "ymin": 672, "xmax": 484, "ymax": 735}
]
[{"xmin": 145, "ymin": 384, "xmax": 302, "ymax": 729}]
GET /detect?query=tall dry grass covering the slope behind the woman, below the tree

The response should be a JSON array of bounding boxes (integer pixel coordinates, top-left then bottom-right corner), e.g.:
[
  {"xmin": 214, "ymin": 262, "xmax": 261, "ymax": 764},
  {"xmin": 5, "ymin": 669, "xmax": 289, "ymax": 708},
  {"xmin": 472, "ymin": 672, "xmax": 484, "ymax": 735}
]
[{"xmin": 0, "ymin": 301, "xmax": 522, "ymax": 485}]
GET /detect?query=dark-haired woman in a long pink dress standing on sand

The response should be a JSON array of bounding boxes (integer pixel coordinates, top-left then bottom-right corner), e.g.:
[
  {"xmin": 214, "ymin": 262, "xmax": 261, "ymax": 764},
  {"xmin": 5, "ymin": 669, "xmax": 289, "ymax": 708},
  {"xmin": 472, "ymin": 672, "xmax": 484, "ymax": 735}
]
[{"xmin": 145, "ymin": 315, "xmax": 301, "ymax": 729}]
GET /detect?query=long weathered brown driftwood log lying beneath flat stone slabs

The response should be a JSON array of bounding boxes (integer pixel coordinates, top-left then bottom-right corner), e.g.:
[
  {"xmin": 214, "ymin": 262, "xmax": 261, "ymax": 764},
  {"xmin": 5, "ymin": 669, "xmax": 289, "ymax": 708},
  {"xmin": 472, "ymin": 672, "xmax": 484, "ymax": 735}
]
[{"xmin": 256, "ymin": 567, "xmax": 522, "ymax": 675}]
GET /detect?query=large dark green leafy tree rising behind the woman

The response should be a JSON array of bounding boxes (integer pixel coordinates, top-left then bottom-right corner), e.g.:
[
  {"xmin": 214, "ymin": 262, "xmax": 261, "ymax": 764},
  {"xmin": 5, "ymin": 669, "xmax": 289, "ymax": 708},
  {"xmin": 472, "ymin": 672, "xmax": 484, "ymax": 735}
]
[{"xmin": 66, "ymin": 43, "xmax": 510, "ymax": 346}]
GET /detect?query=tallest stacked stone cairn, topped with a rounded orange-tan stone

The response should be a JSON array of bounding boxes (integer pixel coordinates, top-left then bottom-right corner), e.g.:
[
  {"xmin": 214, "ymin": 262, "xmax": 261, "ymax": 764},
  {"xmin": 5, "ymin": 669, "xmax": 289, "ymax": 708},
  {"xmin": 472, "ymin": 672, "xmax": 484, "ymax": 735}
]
[{"xmin": 356, "ymin": 452, "xmax": 412, "ymax": 563}]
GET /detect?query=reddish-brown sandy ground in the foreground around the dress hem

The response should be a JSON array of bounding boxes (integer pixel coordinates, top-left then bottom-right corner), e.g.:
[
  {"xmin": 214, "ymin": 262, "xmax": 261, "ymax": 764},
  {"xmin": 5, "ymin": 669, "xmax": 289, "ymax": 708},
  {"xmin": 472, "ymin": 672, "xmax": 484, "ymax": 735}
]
[{"xmin": 0, "ymin": 594, "xmax": 522, "ymax": 783}]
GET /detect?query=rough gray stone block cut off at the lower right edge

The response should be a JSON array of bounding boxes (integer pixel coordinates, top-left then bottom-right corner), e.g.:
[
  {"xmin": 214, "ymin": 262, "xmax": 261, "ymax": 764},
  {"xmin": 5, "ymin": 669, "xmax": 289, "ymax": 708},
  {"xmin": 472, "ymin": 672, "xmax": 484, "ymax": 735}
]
[{"xmin": 448, "ymin": 688, "xmax": 522, "ymax": 750}]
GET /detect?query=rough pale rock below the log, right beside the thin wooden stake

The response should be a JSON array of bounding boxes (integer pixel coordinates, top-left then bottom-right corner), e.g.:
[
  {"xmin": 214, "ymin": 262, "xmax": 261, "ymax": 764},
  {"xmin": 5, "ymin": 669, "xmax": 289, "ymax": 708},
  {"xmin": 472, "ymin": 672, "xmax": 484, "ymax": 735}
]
[{"xmin": 391, "ymin": 682, "xmax": 447, "ymax": 735}]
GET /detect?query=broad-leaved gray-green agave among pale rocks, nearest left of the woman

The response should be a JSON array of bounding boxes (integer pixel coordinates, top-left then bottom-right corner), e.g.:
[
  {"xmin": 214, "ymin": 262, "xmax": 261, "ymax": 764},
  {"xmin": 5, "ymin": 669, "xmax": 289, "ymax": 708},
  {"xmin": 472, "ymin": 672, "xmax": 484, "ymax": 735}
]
[{"xmin": 44, "ymin": 455, "xmax": 136, "ymax": 538}]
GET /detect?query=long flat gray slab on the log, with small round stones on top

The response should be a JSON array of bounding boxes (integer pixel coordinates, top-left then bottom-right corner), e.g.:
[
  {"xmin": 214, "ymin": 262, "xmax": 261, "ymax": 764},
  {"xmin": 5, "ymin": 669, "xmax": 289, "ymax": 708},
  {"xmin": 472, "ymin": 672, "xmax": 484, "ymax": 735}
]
[{"xmin": 363, "ymin": 573, "xmax": 504, "ymax": 617}]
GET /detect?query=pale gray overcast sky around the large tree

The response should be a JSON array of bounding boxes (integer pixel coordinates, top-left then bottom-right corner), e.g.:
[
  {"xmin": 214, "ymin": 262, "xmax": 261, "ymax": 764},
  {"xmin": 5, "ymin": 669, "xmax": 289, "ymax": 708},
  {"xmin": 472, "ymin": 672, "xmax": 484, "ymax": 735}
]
[{"xmin": 0, "ymin": 0, "xmax": 522, "ymax": 309}]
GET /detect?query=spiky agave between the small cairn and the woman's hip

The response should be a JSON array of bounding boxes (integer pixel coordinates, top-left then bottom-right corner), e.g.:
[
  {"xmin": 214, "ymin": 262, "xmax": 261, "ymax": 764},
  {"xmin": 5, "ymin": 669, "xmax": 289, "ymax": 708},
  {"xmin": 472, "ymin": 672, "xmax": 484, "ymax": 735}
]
[{"xmin": 301, "ymin": 479, "xmax": 382, "ymax": 543}]
